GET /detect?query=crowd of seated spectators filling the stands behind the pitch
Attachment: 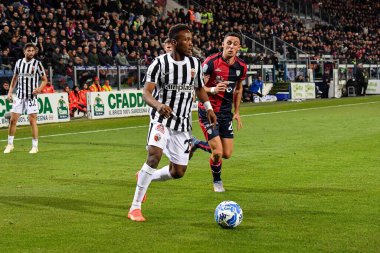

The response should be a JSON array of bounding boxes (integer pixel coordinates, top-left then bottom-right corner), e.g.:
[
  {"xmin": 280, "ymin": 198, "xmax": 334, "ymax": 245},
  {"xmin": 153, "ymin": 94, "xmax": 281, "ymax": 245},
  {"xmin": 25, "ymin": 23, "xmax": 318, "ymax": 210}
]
[{"xmin": 0, "ymin": 0, "xmax": 380, "ymax": 91}]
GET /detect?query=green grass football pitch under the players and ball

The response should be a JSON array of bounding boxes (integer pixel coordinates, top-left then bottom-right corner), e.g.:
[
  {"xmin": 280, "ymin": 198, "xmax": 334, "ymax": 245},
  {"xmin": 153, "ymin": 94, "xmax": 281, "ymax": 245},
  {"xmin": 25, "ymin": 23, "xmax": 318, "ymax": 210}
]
[{"xmin": 0, "ymin": 96, "xmax": 380, "ymax": 252}]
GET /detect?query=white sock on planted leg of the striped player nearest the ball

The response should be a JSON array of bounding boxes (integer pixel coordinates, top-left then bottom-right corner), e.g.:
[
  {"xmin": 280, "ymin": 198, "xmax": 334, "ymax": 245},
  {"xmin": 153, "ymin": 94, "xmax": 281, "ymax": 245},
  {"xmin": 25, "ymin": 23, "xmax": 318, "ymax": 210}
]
[{"xmin": 130, "ymin": 163, "xmax": 156, "ymax": 211}]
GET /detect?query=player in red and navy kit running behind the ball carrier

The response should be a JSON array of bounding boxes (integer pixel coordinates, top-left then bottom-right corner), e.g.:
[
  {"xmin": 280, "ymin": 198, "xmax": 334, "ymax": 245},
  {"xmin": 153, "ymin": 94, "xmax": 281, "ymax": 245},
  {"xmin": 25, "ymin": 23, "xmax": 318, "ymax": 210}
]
[{"xmin": 190, "ymin": 33, "xmax": 247, "ymax": 192}]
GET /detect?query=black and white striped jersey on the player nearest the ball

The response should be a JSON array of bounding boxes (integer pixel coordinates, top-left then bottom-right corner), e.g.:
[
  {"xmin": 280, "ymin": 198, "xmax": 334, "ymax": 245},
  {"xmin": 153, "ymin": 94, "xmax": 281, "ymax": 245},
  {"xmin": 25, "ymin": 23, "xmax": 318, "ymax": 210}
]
[{"xmin": 145, "ymin": 54, "xmax": 204, "ymax": 132}]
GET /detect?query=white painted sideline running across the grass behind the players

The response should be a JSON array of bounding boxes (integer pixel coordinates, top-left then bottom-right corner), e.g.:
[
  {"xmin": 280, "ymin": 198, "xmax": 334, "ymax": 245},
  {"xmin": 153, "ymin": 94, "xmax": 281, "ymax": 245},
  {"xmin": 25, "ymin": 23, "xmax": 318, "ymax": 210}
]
[{"xmin": 0, "ymin": 101, "xmax": 379, "ymax": 142}]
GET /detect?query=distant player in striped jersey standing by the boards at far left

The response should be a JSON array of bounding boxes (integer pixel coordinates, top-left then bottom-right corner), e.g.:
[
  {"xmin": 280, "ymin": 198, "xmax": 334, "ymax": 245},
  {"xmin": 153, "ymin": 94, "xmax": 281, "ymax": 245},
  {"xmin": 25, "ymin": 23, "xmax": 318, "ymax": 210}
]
[{"xmin": 4, "ymin": 43, "xmax": 47, "ymax": 154}]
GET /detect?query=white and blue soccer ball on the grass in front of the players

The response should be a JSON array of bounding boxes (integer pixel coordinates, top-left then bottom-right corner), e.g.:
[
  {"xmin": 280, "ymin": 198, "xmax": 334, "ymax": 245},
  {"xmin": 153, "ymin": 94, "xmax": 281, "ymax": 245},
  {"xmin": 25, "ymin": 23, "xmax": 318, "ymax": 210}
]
[{"xmin": 215, "ymin": 201, "xmax": 243, "ymax": 228}]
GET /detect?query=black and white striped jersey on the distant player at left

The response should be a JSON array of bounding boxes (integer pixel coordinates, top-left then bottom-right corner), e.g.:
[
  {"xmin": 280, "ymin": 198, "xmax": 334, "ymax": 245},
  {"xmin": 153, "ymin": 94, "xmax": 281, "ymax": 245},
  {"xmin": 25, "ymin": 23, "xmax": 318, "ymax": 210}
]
[{"xmin": 14, "ymin": 58, "xmax": 45, "ymax": 99}]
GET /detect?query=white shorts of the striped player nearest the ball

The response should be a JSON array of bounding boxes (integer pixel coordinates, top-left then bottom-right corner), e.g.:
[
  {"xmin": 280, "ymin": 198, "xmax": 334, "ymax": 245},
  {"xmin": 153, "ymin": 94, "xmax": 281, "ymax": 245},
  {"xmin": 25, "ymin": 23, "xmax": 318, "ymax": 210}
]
[{"xmin": 148, "ymin": 122, "xmax": 191, "ymax": 165}]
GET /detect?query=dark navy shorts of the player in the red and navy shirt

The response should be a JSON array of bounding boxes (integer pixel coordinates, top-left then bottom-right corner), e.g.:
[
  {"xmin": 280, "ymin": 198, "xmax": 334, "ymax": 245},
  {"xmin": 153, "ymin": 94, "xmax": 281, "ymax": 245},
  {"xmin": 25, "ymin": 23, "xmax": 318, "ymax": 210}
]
[{"xmin": 198, "ymin": 108, "xmax": 234, "ymax": 141}]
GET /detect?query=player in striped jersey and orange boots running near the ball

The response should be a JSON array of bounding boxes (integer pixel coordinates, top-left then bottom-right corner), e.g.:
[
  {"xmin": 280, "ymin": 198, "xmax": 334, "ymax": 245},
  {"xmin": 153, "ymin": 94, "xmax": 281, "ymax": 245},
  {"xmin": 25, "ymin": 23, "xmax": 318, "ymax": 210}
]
[{"xmin": 128, "ymin": 24, "xmax": 216, "ymax": 221}]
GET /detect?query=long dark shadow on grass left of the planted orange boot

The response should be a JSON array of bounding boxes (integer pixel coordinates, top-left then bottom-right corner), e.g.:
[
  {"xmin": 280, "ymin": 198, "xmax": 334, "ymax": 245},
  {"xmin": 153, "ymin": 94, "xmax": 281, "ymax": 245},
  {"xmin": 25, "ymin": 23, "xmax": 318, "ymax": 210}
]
[{"xmin": 0, "ymin": 196, "xmax": 128, "ymax": 218}]
